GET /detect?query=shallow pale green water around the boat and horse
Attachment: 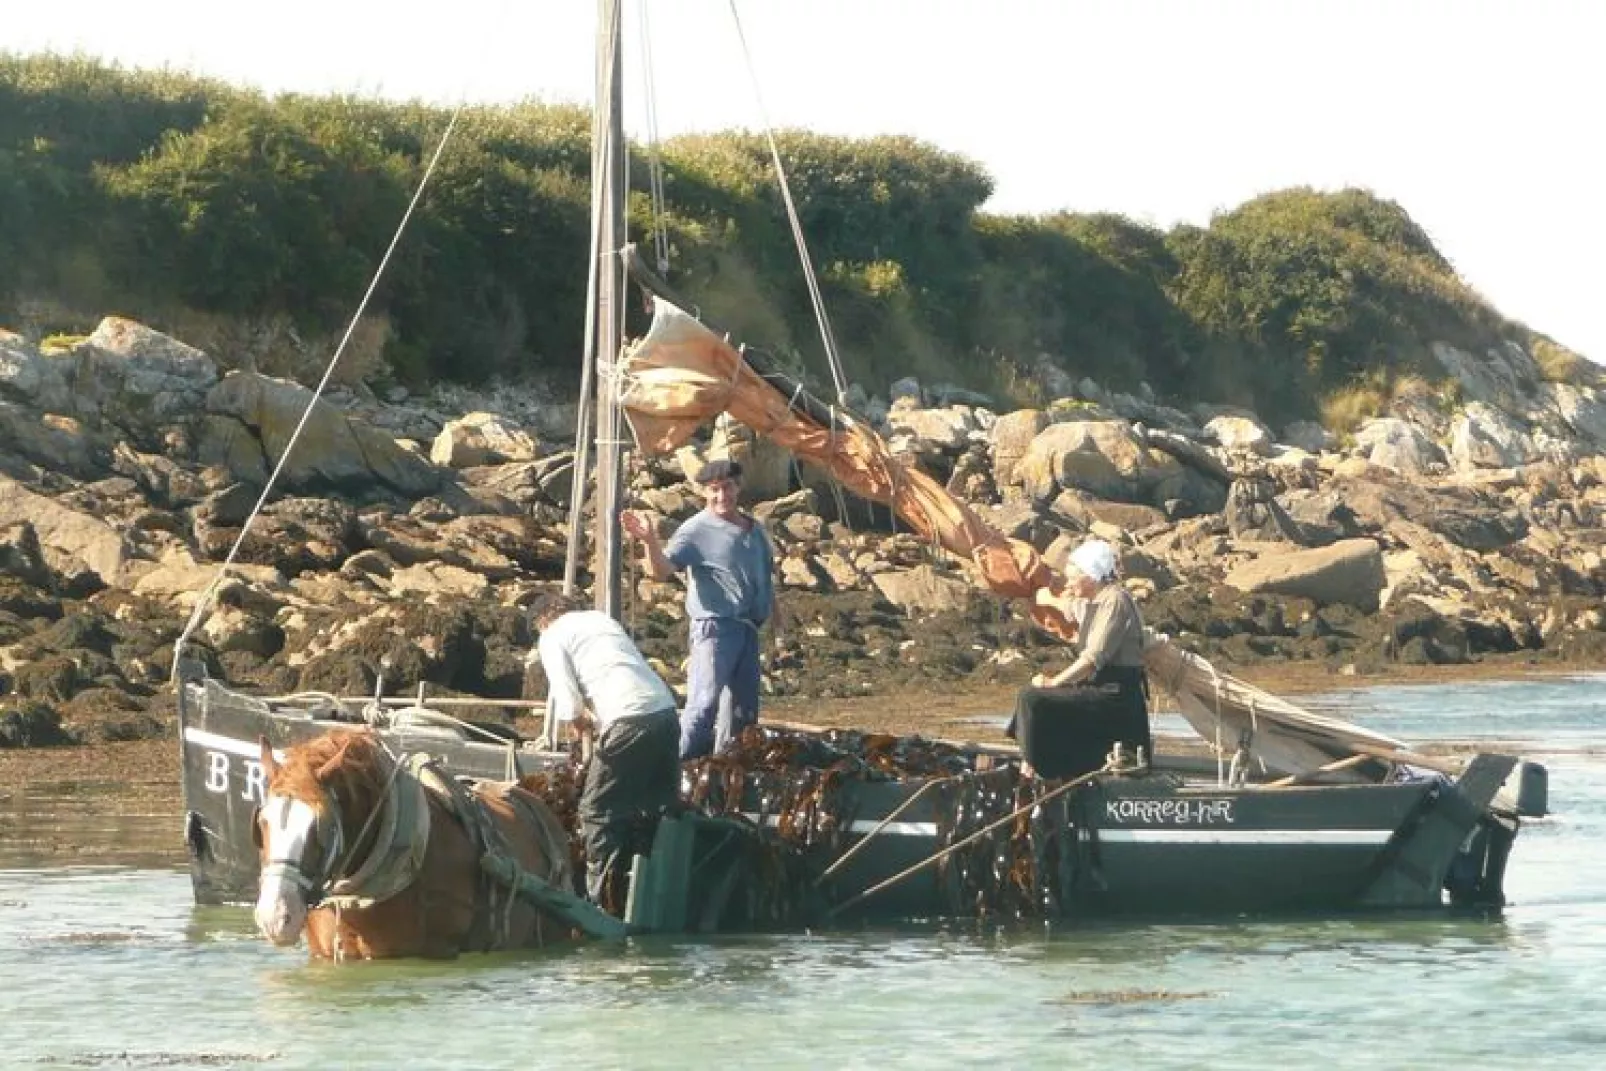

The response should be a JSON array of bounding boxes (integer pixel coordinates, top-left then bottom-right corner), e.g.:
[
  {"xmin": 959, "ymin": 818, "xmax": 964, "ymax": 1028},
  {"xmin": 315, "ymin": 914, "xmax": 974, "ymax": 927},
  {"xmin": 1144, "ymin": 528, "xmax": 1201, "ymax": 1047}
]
[{"xmin": 0, "ymin": 678, "xmax": 1606, "ymax": 1069}]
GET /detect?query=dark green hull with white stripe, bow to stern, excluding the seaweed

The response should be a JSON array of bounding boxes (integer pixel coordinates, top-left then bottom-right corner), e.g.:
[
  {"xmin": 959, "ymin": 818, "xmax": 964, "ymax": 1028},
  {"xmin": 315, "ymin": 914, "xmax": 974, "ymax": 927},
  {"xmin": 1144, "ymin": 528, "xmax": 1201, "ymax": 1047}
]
[{"xmin": 180, "ymin": 681, "xmax": 1516, "ymax": 922}]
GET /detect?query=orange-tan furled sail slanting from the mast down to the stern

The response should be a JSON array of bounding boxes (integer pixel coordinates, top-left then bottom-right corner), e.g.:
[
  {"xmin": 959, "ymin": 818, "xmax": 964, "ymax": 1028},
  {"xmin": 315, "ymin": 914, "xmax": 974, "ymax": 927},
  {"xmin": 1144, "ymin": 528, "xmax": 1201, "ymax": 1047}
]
[{"xmin": 615, "ymin": 297, "xmax": 1404, "ymax": 777}]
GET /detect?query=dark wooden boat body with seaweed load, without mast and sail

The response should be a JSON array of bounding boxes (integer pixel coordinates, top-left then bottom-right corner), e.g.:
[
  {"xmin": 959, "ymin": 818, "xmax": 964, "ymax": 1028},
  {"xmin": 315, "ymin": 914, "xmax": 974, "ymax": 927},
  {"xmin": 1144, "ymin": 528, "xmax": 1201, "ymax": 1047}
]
[{"xmin": 180, "ymin": 658, "xmax": 1545, "ymax": 930}]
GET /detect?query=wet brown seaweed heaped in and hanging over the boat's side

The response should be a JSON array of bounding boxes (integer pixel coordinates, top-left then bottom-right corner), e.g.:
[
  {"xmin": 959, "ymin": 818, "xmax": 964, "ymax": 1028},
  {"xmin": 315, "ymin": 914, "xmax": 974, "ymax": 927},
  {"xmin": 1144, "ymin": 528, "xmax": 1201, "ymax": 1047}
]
[{"xmin": 522, "ymin": 726, "xmax": 1097, "ymax": 926}]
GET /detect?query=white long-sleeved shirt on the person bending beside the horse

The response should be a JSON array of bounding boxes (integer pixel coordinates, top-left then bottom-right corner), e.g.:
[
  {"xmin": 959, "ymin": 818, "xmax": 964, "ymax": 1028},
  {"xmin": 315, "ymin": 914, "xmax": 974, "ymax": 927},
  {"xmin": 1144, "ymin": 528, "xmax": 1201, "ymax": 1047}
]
[{"xmin": 527, "ymin": 610, "xmax": 675, "ymax": 735}]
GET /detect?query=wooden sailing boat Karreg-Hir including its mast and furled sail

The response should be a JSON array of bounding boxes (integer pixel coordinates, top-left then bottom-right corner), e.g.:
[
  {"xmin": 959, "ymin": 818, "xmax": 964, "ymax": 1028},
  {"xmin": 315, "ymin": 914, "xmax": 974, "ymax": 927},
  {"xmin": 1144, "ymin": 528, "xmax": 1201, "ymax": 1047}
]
[{"xmin": 175, "ymin": 0, "xmax": 1543, "ymax": 930}]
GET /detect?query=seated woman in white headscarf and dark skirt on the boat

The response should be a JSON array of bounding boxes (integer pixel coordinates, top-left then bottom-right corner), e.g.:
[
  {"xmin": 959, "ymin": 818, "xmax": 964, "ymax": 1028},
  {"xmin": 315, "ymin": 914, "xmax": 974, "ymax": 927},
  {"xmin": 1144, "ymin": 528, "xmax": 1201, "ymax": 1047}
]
[{"xmin": 1010, "ymin": 540, "xmax": 1153, "ymax": 777}]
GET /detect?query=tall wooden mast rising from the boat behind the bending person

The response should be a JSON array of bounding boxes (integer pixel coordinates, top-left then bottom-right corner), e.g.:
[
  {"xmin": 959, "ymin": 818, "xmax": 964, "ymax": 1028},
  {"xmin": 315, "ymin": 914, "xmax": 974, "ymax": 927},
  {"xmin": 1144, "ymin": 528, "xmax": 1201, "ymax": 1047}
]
[{"xmin": 564, "ymin": 0, "xmax": 626, "ymax": 618}]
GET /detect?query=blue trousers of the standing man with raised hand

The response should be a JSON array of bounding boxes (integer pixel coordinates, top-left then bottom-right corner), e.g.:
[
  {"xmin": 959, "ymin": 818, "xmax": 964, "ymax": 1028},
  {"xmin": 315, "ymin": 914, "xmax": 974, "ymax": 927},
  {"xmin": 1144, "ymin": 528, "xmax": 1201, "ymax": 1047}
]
[{"xmin": 681, "ymin": 617, "xmax": 758, "ymax": 763}]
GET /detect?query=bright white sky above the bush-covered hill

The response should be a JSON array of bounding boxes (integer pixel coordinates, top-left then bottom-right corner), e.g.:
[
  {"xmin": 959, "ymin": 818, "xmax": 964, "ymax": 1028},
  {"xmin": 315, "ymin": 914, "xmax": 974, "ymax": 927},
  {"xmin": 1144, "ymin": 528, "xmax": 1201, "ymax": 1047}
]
[{"xmin": 12, "ymin": 0, "xmax": 1606, "ymax": 361}]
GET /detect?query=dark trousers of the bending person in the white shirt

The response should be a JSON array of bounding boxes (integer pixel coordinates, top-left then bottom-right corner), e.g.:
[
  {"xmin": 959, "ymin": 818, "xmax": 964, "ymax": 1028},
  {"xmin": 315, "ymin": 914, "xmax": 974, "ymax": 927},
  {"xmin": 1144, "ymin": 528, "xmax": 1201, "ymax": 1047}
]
[{"xmin": 580, "ymin": 707, "xmax": 681, "ymax": 914}]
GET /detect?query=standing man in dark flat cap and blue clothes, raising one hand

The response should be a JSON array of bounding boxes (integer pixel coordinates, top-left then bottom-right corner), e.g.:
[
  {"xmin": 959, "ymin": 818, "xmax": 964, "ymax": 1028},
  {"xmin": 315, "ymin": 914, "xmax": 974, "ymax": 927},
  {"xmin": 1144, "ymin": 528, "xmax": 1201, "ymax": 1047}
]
[{"xmin": 622, "ymin": 458, "xmax": 779, "ymax": 761}]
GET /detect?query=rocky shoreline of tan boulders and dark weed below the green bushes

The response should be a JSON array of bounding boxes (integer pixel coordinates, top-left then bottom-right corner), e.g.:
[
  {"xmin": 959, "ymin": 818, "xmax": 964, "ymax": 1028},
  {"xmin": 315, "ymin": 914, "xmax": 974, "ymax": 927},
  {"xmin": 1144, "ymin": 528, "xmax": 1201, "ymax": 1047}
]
[{"xmin": 0, "ymin": 318, "xmax": 1606, "ymax": 750}]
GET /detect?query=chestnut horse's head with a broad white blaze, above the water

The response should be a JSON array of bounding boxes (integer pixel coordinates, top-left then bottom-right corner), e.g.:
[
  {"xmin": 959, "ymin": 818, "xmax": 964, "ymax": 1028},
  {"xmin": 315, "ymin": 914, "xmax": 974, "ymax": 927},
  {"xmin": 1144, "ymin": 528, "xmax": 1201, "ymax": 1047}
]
[{"xmin": 254, "ymin": 731, "xmax": 385, "ymax": 946}]
